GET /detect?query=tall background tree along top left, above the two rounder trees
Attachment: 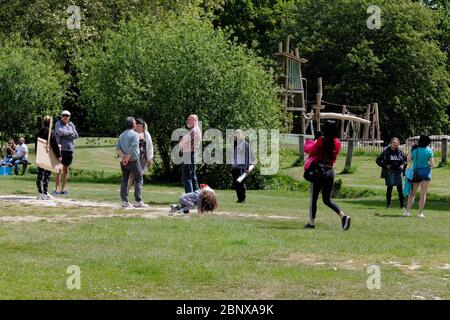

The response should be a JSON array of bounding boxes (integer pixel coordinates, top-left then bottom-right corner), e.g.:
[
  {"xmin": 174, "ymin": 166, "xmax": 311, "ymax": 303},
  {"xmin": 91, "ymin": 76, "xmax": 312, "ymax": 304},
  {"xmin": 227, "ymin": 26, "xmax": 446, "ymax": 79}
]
[{"xmin": 0, "ymin": 0, "xmax": 222, "ymax": 134}]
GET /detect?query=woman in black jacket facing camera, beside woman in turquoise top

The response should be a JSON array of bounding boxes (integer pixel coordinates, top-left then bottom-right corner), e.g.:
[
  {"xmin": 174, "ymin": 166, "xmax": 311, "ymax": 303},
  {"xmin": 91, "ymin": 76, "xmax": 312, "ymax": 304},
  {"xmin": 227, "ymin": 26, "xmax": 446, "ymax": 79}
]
[{"xmin": 376, "ymin": 137, "xmax": 407, "ymax": 209}]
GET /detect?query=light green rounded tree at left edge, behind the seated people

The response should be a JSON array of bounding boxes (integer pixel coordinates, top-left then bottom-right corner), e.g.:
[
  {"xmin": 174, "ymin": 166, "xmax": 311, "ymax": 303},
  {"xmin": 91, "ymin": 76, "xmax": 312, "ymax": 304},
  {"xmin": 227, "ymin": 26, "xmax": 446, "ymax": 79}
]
[{"xmin": 0, "ymin": 35, "xmax": 66, "ymax": 151}]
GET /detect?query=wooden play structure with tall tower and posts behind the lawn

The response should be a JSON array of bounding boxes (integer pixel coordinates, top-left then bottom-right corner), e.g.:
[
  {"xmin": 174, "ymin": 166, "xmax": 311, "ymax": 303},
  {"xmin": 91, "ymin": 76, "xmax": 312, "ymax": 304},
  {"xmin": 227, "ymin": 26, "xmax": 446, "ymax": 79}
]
[{"xmin": 275, "ymin": 36, "xmax": 382, "ymax": 145}]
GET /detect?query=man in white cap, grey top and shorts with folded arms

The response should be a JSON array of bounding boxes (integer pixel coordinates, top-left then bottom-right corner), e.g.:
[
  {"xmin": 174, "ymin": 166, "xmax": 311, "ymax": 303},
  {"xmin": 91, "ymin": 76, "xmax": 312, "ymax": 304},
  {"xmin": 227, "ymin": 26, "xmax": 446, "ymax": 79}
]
[{"xmin": 53, "ymin": 110, "xmax": 79, "ymax": 195}]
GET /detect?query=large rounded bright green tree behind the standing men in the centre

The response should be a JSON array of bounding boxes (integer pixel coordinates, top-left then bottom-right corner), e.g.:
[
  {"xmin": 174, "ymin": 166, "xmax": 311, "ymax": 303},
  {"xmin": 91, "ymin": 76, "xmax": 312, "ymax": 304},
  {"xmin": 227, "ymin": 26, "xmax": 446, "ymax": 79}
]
[{"xmin": 81, "ymin": 17, "xmax": 281, "ymax": 175}]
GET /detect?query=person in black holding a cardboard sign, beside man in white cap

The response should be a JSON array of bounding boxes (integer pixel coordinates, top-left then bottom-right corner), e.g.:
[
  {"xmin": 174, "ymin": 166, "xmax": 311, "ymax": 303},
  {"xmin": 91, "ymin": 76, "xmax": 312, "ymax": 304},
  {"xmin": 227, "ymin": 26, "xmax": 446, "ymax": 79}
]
[{"xmin": 35, "ymin": 116, "xmax": 62, "ymax": 200}]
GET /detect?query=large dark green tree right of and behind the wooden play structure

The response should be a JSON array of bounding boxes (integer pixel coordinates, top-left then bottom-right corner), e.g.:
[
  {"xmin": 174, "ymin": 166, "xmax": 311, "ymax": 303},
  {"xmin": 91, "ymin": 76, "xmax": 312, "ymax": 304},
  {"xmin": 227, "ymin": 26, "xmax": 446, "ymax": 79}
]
[{"xmin": 278, "ymin": 0, "xmax": 450, "ymax": 139}]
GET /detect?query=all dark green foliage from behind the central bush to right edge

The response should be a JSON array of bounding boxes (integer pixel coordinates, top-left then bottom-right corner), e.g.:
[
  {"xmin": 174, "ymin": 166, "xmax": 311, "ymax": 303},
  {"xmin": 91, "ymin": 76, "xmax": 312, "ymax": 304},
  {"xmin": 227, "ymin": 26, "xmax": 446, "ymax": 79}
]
[{"xmin": 215, "ymin": 0, "xmax": 450, "ymax": 139}]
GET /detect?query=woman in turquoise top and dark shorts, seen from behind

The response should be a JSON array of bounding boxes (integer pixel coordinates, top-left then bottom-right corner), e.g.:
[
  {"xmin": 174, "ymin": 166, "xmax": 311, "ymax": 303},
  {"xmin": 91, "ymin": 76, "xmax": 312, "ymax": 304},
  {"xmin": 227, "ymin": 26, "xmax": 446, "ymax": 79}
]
[{"xmin": 403, "ymin": 135, "xmax": 434, "ymax": 218}]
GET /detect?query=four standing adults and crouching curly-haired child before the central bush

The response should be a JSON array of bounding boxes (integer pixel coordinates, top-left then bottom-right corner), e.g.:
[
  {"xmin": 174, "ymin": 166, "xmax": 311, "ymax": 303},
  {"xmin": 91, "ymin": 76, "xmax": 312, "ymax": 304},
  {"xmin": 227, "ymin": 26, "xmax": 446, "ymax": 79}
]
[{"xmin": 116, "ymin": 114, "xmax": 256, "ymax": 214}]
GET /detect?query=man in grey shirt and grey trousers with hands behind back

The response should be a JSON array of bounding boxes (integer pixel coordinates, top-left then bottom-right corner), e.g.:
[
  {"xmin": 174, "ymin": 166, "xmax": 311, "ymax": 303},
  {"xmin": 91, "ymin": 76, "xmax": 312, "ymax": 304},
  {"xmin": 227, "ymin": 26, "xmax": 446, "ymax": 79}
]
[{"xmin": 116, "ymin": 117, "xmax": 147, "ymax": 208}]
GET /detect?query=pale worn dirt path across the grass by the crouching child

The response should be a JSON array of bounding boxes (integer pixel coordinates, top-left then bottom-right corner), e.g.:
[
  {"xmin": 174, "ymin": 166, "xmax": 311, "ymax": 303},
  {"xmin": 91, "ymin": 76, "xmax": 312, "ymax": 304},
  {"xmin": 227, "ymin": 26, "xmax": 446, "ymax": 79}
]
[{"xmin": 0, "ymin": 195, "xmax": 297, "ymax": 223}]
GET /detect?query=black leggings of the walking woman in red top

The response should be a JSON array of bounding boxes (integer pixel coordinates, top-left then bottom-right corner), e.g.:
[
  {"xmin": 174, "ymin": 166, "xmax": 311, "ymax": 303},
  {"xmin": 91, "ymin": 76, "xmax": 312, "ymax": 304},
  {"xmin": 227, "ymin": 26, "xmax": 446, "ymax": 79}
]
[{"xmin": 309, "ymin": 169, "xmax": 341, "ymax": 219}]
